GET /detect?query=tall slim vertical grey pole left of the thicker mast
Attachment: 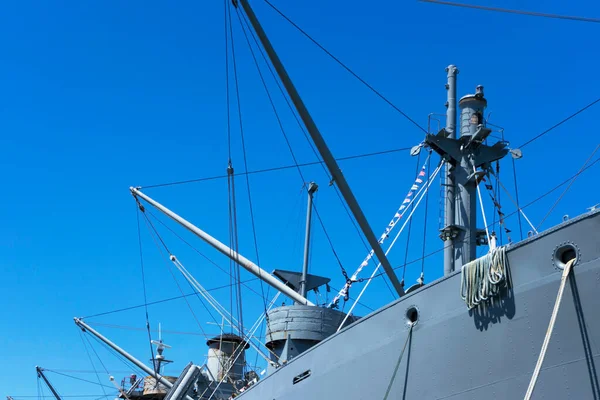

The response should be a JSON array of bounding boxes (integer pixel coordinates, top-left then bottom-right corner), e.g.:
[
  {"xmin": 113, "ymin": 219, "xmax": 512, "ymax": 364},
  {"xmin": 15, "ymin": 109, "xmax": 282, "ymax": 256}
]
[{"xmin": 444, "ymin": 65, "xmax": 458, "ymax": 275}]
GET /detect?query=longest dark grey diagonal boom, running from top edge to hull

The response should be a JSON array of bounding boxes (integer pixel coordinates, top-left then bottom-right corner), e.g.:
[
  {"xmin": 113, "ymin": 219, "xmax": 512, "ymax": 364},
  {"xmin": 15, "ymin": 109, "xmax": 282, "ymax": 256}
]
[{"xmin": 234, "ymin": 0, "xmax": 404, "ymax": 296}]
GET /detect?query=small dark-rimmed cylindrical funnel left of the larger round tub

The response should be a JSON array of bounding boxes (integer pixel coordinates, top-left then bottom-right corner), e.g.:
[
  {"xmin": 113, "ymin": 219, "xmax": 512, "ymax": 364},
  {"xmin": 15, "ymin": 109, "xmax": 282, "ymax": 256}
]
[{"xmin": 206, "ymin": 333, "xmax": 250, "ymax": 383}]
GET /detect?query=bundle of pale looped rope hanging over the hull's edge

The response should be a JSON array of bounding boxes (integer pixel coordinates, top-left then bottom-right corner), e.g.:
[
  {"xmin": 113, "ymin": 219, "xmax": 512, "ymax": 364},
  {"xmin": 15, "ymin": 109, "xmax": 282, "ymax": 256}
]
[{"xmin": 460, "ymin": 246, "xmax": 508, "ymax": 310}]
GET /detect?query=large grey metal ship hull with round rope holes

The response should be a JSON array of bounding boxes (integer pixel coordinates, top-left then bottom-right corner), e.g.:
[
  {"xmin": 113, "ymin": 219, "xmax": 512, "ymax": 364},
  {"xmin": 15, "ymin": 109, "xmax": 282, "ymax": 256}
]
[{"xmin": 238, "ymin": 211, "xmax": 600, "ymax": 400}]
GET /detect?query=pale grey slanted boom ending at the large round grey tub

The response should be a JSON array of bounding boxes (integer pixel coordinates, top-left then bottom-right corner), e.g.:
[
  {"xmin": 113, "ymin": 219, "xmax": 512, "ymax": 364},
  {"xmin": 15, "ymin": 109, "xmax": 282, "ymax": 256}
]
[{"xmin": 130, "ymin": 187, "xmax": 314, "ymax": 306}]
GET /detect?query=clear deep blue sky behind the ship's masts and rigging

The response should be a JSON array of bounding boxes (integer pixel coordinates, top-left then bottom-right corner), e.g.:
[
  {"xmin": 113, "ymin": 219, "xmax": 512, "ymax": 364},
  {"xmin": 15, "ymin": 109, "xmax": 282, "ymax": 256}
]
[{"xmin": 0, "ymin": 0, "xmax": 600, "ymax": 396}]
